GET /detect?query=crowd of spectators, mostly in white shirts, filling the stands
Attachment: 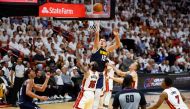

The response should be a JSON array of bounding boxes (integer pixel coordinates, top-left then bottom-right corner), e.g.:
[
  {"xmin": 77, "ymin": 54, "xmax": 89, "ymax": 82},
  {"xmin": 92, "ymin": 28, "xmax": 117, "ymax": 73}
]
[{"xmin": 0, "ymin": 0, "xmax": 190, "ymax": 105}]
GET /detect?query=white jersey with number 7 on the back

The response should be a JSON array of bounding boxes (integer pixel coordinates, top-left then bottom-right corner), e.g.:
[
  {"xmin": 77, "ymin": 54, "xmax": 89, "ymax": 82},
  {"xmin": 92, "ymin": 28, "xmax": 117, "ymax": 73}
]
[{"xmin": 164, "ymin": 87, "xmax": 188, "ymax": 109}]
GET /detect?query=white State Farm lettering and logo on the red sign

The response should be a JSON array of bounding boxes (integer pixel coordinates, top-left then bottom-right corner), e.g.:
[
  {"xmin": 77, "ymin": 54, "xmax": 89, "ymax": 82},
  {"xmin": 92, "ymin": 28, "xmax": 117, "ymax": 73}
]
[{"xmin": 42, "ymin": 7, "xmax": 74, "ymax": 14}]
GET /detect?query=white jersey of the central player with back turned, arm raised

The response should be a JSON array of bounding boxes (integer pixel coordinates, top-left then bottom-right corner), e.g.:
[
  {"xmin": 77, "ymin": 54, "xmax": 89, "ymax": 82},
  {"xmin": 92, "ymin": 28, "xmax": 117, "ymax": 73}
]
[{"xmin": 82, "ymin": 70, "xmax": 99, "ymax": 91}]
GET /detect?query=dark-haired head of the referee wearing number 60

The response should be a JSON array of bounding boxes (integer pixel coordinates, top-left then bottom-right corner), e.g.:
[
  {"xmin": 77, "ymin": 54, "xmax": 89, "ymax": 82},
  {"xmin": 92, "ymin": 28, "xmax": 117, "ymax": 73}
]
[{"xmin": 122, "ymin": 75, "xmax": 133, "ymax": 88}]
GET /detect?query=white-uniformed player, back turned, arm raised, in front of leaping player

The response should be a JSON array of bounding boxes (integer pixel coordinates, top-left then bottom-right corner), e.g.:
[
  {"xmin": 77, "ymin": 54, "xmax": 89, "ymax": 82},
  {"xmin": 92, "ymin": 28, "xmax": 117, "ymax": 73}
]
[{"xmin": 73, "ymin": 50, "xmax": 99, "ymax": 109}]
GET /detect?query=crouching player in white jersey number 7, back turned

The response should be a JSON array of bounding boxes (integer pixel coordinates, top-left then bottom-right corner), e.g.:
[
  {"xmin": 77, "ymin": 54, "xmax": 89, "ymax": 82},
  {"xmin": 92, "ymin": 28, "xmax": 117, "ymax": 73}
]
[{"xmin": 149, "ymin": 77, "xmax": 188, "ymax": 109}]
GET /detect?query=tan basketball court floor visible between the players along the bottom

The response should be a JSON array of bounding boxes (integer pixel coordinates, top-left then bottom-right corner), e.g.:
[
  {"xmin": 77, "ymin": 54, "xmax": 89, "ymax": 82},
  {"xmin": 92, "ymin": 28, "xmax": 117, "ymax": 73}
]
[{"xmin": 5, "ymin": 92, "xmax": 190, "ymax": 109}]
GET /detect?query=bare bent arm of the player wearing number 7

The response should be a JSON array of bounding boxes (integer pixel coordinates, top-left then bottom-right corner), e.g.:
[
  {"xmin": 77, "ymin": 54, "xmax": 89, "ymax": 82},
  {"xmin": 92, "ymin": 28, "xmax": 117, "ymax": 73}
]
[{"xmin": 148, "ymin": 92, "xmax": 167, "ymax": 109}]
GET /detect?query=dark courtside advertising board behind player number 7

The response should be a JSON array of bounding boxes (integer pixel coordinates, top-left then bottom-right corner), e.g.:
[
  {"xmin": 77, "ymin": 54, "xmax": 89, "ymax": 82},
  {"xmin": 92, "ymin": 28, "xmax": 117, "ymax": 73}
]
[{"xmin": 138, "ymin": 73, "xmax": 190, "ymax": 90}]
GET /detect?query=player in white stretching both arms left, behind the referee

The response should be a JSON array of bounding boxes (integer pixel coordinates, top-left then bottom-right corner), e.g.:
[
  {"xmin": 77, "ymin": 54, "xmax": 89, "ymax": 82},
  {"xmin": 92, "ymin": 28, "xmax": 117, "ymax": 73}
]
[{"xmin": 108, "ymin": 62, "xmax": 140, "ymax": 89}]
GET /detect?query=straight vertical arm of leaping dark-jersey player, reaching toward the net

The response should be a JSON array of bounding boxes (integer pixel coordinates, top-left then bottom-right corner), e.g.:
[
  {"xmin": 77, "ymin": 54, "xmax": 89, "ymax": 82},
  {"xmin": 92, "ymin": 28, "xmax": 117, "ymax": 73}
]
[{"xmin": 92, "ymin": 21, "xmax": 100, "ymax": 53}]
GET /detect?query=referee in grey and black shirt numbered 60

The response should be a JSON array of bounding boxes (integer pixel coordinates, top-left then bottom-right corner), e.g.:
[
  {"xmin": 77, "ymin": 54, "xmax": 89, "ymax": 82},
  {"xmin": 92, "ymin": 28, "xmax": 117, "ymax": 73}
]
[{"xmin": 112, "ymin": 75, "xmax": 146, "ymax": 109}]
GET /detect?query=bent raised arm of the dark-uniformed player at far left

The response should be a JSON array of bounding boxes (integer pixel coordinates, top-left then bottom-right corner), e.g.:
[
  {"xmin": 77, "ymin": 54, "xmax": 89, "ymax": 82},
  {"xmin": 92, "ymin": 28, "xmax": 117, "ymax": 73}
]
[{"xmin": 34, "ymin": 73, "xmax": 50, "ymax": 92}]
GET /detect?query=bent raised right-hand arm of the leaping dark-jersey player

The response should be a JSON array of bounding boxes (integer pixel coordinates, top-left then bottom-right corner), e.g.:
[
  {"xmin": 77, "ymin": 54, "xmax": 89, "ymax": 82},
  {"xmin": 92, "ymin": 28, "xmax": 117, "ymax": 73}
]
[{"xmin": 107, "ymin": 29, "xmax": 121, "ymax": 52}]
